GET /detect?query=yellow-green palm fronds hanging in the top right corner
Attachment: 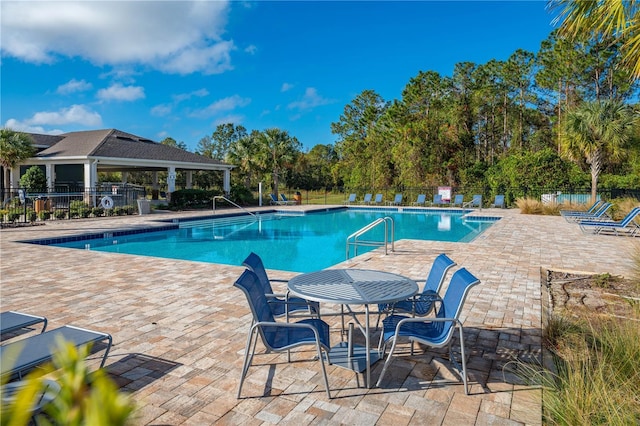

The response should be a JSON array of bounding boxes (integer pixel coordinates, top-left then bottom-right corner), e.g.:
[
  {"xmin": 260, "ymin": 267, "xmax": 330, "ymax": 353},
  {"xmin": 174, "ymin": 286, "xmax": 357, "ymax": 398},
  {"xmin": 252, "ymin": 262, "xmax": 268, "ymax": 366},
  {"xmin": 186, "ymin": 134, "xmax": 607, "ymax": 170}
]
[{"xmin": 549, "ymin": 0, "xmax": 640, "ymax": 79}]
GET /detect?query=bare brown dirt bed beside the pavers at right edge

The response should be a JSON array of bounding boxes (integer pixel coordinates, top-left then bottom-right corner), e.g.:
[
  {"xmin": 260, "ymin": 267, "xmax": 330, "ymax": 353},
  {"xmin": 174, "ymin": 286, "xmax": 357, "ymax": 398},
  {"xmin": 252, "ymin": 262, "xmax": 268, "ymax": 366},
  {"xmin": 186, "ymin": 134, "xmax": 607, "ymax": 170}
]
[{"xmin": 547, "ymin": 271, "xmax": 640, "ymax": 317}]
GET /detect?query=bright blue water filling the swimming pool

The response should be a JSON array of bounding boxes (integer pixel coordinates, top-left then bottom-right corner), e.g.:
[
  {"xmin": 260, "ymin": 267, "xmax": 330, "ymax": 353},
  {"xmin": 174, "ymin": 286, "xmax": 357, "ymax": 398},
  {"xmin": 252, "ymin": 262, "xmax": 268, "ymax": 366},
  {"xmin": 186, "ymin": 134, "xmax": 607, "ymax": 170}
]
[{"xmin": 46, "ymin": 208, "xmax": 495, "ymax": 272}]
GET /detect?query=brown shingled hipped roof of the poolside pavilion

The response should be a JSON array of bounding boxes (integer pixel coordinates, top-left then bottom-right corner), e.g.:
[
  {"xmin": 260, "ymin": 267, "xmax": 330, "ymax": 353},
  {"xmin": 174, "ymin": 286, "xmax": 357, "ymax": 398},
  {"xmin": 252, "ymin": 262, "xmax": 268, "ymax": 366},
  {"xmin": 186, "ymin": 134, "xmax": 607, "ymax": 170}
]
[{"xmin": 31, "ymin": 129, "xmax": 233, "ymax": 169}]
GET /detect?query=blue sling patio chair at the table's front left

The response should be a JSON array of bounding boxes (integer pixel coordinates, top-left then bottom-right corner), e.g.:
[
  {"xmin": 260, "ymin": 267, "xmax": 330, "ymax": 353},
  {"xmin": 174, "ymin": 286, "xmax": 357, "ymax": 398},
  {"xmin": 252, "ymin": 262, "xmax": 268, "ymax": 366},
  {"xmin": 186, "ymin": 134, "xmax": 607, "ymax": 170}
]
[{"xmin": 233, "ymin": 269, "xmax": 331, "ymax": 398}]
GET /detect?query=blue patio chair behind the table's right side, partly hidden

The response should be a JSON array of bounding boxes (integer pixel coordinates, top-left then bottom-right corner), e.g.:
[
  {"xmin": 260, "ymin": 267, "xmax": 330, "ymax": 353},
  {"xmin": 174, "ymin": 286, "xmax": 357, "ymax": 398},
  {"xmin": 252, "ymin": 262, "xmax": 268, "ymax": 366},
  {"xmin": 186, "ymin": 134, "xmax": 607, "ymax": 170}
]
[{"xmin": 376, "ymin": 253, "xmax": 456, "ymax": 328}]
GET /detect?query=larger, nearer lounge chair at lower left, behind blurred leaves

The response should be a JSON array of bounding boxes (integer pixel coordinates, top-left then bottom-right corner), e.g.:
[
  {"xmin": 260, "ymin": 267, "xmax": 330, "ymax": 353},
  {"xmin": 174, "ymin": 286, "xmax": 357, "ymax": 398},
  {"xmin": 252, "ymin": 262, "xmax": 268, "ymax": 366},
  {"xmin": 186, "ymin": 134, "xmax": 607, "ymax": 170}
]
[{"xmin": 0, "ymin": 325, "xmax": 112, "ymax": 378}]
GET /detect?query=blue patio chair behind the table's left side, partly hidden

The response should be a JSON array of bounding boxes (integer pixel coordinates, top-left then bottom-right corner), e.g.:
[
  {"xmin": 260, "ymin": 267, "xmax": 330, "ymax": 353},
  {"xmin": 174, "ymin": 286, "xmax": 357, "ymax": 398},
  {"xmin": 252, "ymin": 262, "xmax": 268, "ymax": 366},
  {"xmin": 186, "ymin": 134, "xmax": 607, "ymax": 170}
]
[{"xmin": 242, "ymin": 252, "xmax": 320, "ymax": 320}]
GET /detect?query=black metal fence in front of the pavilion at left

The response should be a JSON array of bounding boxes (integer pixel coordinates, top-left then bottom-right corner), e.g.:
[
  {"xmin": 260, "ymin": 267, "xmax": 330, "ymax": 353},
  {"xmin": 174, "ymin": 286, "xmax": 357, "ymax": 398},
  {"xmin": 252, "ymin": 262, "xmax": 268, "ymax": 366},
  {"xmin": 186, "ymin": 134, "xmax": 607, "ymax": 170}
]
[{"xmin": 0, "ymin": 184, "xmax": 146, "ymax": 226}]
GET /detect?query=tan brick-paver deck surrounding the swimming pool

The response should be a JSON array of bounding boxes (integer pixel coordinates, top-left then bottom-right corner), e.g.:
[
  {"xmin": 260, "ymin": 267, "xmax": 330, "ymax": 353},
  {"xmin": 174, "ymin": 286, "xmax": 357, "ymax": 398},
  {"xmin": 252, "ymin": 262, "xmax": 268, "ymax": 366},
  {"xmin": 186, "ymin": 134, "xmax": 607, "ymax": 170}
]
[{"xmin": 0, "ymin": 206, "xmax": 640, "ymax": 426}]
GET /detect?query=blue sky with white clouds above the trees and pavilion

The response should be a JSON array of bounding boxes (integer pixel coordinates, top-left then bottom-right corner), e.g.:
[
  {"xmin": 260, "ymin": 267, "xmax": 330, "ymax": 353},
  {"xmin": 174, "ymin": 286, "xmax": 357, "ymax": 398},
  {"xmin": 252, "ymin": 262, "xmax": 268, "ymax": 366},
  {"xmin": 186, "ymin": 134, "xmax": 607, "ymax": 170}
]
[{"xmin": 0, "ymin": 0, "xmax": 553, "ymax": 151}]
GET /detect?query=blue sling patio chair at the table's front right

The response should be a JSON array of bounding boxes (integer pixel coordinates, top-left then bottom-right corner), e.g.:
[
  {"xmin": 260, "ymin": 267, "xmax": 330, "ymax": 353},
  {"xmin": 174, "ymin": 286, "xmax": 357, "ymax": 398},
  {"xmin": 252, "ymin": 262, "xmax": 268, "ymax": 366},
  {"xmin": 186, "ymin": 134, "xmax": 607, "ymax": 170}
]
[{"xmin": 377, "ymin": 268, "xmax": 480, "ymax": 395}]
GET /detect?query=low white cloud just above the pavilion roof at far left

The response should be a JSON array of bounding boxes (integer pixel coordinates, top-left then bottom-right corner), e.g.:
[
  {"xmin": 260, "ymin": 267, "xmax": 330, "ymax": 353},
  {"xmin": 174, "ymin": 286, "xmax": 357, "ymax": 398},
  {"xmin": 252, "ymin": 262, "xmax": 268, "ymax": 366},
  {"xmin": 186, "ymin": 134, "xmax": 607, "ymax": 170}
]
[{"xmin": 6, "ymin": 105, "xmax": 102, "ymax": 134}]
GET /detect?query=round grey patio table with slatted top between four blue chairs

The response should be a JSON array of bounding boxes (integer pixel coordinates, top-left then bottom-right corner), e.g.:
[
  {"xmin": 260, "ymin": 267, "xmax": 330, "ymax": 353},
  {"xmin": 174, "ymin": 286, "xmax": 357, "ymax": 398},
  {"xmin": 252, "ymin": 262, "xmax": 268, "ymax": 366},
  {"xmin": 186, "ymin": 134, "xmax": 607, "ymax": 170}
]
[{"xmin": 287, "ymin": 269, "xmax": 418, "ymax": 387}]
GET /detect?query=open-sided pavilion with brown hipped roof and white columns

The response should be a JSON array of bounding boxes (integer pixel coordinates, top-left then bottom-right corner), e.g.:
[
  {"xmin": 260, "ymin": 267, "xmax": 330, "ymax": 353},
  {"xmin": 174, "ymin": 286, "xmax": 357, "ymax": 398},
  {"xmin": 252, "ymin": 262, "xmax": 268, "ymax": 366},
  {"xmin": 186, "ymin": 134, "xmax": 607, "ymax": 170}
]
[{"xmin": 11, "ymin": 129, "xmax": 234, "ymax": 194}]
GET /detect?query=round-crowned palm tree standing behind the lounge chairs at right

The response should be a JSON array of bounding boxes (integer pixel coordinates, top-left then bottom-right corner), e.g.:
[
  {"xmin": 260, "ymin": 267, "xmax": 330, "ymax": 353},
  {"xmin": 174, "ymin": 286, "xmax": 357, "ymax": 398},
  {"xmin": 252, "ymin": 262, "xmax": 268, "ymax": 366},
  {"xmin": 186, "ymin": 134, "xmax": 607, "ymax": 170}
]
[{"xmin": 561, "ymin": 100, "xmax": 634, "ymax": 200}]
